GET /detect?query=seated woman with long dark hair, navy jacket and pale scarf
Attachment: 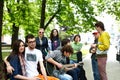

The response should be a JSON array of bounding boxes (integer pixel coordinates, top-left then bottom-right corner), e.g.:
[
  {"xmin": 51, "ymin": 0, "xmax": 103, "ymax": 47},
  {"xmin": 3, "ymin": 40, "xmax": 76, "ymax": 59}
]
[{"xmin": 7, "ymin": 40, "xmax": 37, "ymax": 80}]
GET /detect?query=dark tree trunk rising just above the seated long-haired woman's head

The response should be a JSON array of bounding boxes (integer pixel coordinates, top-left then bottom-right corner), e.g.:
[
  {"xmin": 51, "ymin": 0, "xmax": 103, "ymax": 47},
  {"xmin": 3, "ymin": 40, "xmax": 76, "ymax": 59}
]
[{"xmin": 11, "ymin": 23, "xmax": 19, "ymax": 46}]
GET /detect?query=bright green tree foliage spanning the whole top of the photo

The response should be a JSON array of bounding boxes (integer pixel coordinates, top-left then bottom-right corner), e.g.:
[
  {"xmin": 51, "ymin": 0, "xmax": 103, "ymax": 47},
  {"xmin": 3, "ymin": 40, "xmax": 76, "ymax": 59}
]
[{"xmin": 3, "ymin": 0, "xmax": 120, "ymax": 36}]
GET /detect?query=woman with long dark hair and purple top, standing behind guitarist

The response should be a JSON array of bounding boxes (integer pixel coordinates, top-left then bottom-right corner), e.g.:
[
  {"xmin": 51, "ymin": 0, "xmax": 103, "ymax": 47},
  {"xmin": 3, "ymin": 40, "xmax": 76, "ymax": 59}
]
[{"xmin": 50, "ymin": 29, "xmax": 61, "ymax": 51}]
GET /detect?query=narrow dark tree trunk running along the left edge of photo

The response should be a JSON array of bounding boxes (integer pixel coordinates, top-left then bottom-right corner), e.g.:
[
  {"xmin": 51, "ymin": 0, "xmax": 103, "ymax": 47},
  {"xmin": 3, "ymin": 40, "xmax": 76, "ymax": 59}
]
[{"xmin": 0, "ymin": 0, "xmax": 4, "ymax": 63}]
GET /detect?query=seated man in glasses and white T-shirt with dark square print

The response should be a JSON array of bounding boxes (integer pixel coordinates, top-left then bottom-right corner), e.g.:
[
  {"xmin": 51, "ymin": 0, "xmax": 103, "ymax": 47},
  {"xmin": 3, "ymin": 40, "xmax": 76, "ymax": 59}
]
[{"xmin": 25, "ymin": 34, "xmax": 47, "ymax": 80}]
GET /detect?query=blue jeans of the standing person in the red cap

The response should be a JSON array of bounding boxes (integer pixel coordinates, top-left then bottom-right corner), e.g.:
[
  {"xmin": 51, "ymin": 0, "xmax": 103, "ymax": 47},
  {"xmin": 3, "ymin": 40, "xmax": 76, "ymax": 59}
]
[{"xmin": 92, "ymin": 58, "xmax": 100, "ymax": 80}]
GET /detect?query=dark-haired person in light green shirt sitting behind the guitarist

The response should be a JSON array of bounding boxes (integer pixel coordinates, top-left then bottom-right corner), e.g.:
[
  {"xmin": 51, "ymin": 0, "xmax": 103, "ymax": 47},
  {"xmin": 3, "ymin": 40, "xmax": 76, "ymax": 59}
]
[{"xmin": 70, "ymin": 35, "xmax": 87, "ymax": 80}]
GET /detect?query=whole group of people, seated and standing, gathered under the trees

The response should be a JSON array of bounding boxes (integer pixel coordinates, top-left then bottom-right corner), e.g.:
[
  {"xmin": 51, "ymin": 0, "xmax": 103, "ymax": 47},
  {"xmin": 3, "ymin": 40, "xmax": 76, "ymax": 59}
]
[{"xmin": 4, "ymin": 22, "xmax": 109, "ymax": 80}]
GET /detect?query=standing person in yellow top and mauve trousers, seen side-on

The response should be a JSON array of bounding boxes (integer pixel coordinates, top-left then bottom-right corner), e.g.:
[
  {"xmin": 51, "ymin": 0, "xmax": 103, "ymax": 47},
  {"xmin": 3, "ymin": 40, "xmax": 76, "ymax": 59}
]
[{"xmin": 92, "ymin": 21, "xmax": 110, "ymax": 80}]
